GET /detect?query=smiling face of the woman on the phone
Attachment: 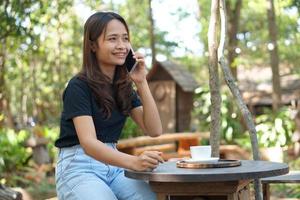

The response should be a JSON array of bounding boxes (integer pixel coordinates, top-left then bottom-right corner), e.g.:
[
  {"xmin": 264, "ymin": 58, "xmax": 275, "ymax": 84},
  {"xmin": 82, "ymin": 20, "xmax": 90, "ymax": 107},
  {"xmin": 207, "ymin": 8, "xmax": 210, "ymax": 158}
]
[{"xmin": 95, "ymin": 19, "xmax": 130, "ymax": 68}]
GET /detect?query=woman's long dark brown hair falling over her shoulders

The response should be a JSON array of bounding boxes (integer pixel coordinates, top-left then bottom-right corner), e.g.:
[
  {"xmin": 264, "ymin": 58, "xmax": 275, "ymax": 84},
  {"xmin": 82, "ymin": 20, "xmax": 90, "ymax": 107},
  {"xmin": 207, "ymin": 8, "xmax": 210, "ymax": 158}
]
[{"xmin": 78, "ymin": 12, "xmax": 133, "ymax": 119}]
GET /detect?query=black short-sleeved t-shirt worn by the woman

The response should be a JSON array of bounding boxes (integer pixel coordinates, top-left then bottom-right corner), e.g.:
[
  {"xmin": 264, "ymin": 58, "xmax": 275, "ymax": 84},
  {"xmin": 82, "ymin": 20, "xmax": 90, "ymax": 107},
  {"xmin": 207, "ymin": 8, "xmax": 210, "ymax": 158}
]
[{"xmin": 55, "ymin": 77, "xmax": 141, "ymax": 148}]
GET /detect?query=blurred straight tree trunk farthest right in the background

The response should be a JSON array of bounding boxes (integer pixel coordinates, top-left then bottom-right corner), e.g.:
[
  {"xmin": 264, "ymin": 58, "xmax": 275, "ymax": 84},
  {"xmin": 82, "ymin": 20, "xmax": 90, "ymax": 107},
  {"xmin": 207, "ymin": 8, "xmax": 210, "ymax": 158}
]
[{"xmin": 267, "ymin": 0, "xmax": 281, "ymax": 111}]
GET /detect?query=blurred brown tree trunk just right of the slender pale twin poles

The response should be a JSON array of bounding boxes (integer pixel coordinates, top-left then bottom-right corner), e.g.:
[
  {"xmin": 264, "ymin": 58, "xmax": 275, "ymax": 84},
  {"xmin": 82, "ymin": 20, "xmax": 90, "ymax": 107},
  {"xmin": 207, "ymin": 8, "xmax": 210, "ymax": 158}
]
[{"xmin": 226, "ymin": 0, "xmax": 242, "ymax": 80}]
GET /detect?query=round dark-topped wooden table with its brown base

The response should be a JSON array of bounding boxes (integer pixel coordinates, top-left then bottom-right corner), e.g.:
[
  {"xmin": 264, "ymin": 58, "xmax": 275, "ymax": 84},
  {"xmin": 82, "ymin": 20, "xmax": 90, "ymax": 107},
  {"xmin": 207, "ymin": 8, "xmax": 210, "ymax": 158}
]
[{"xmin": 125, "ymin": 160, "xmax": 289, "ymax": 200}]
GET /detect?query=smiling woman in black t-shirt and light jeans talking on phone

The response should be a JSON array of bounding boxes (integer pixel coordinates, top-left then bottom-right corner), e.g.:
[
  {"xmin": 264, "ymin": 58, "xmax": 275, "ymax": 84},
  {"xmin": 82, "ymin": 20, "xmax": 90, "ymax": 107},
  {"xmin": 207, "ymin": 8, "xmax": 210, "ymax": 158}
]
[{"xmin": 55, "ymin": 12, "xmax": 163, "ymax": 200}]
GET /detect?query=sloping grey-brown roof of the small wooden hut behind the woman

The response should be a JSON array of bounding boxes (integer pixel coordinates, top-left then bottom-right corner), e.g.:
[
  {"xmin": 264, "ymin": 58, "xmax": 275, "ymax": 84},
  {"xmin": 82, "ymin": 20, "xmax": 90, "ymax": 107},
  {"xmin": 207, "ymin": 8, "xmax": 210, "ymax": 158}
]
[{"xmin": 148, "ymin": 61, "xmax": 199, "ymax": 92}]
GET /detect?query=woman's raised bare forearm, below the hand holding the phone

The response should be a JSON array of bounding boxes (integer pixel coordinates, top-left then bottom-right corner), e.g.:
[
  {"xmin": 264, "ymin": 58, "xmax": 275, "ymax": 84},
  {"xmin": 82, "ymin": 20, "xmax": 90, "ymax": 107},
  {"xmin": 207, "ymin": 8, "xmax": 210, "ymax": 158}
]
[{"xmin": 136, "ymin": 80, "xmax": 162, "ymax": 137}]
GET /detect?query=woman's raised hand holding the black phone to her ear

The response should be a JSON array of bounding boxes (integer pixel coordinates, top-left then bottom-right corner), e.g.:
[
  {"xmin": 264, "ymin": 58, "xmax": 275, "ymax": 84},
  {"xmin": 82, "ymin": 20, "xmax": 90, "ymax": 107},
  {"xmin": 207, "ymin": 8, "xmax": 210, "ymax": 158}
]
[{"xmin": 129, "ymin": 52, "xmax": 146, "ymax": 84}]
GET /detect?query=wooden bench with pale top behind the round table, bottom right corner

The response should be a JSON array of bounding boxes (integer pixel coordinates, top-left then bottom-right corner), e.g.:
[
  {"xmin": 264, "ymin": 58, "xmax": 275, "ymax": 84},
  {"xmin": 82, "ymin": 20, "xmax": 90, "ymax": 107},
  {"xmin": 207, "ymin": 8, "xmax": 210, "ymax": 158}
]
[{"xmin": 261, "ymin": 171, "xmax": 300, "ymax": 200}]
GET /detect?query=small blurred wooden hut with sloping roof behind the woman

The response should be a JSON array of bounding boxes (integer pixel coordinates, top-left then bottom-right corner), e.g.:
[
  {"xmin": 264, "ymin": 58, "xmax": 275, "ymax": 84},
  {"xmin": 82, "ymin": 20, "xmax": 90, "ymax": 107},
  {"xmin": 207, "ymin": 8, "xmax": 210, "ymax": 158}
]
[{"xmin": 147, "ymin": 61, "xmax": 198, "ymax": 133}]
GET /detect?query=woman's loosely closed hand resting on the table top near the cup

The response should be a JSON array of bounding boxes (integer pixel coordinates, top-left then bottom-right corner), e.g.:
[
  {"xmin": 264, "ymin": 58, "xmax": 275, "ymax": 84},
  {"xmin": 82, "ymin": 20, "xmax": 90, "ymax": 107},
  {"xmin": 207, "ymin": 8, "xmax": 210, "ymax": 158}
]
[{"xmin": 133, "ymin": 151, "xmax": 164, "ymax": 171}]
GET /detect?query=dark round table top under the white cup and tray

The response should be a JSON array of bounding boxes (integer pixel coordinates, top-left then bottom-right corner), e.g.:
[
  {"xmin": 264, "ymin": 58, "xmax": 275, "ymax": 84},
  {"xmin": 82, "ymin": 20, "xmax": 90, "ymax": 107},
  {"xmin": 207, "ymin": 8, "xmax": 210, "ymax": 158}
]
[{"xmin": 125, "ymin": 160, "xmax": 289, "ymax": 182}]
